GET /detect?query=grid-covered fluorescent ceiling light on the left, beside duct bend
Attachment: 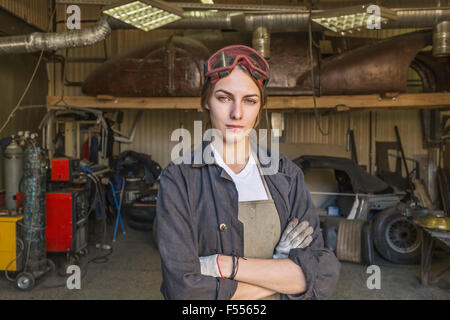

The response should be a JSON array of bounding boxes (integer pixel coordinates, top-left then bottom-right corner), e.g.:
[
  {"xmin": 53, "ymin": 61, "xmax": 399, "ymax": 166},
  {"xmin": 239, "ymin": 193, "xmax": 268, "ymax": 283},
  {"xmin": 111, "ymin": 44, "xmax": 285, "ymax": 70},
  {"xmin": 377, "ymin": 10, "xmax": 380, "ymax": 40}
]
[{"xmin": 103, "ymin": 0, "xmax": 183, "ymax": 31}]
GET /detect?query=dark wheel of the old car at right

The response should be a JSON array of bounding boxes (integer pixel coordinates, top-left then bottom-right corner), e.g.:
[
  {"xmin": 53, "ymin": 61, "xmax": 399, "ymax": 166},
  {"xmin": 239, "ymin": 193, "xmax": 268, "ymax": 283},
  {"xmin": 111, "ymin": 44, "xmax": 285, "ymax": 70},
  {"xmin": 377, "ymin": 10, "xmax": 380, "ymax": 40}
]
[{"xmin": 373, "ymin": 208, "xmax": 422, "ymax": 264}]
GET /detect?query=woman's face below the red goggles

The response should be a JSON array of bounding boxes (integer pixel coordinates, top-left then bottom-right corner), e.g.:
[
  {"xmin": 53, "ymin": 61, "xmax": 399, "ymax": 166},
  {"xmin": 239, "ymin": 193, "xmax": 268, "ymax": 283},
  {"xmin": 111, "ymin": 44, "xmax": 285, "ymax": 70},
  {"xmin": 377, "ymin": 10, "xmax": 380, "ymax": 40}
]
[{"xmin": 205, "ymin": 67, "xmax": 261, "ymax": 143}]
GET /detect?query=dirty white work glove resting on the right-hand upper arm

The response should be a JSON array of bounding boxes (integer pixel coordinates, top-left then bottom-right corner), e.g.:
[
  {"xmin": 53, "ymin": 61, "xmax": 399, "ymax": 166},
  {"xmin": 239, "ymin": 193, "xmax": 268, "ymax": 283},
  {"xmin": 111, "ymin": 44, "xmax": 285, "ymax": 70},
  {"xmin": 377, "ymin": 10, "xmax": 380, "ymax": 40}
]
[{"xmin": 273, "ymin": 218, "xmax": 314, "ymax": 259}]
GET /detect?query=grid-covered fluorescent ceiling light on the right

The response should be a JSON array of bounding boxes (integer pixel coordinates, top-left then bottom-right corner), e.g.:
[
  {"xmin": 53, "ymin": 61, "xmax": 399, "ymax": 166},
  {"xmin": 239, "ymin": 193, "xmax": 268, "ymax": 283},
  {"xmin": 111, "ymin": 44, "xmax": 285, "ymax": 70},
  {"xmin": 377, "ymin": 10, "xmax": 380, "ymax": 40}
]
[{"xmin": 311, "ymin": 5, "xmax": 397, "ymax": 34}]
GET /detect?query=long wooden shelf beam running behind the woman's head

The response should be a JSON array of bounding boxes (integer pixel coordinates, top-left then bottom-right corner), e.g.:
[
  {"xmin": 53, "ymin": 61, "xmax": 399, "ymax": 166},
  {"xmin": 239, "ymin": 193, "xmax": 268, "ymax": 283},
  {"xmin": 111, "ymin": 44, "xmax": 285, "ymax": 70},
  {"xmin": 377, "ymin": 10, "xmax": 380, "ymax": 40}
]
[{"xmin": 47, "ymin": 92, "xmax": 450, "ymax": 111}]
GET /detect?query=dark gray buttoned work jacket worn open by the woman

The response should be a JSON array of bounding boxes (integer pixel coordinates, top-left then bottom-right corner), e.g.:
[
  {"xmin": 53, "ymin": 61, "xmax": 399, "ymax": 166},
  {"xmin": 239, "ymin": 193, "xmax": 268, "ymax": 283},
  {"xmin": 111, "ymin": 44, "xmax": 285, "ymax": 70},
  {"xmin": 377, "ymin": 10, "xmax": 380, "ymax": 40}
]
[{"xmin": 156, "ymin": 142, "xmax": 340, "ymax": 300}]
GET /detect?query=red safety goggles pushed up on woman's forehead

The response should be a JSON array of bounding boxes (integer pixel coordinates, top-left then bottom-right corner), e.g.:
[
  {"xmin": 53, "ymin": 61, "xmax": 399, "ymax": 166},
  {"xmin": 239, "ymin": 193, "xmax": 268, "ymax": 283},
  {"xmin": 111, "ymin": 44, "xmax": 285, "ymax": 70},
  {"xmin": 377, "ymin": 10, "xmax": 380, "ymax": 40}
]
[{"xmin": 204, "ymin": 45, "xmax": 270, "ymax": 86}]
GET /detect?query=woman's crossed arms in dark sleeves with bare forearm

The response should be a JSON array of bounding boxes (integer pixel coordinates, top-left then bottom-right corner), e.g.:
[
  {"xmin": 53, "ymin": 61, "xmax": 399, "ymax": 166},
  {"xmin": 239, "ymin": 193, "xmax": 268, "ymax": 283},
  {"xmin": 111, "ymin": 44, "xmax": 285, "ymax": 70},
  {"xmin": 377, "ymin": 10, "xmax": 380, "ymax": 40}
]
[{"xmin": 157, "ymin": 166, "xmax": 340, "ymax": 300}]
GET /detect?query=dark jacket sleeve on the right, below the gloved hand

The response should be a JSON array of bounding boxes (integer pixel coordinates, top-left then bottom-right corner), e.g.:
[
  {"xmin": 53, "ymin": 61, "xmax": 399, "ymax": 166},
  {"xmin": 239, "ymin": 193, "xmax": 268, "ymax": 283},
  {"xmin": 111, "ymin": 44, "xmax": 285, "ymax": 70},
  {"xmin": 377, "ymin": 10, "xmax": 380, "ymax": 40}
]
[{"xmin": 283, "ymin": 170, "xmax": 340, "ymax": 300}]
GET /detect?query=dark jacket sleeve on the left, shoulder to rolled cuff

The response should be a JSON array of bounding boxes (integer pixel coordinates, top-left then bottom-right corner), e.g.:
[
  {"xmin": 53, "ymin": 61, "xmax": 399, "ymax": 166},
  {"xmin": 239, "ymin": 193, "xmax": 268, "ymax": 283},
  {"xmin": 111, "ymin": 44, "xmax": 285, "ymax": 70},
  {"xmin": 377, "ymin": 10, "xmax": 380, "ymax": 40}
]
[{"xmin": 156, "ymin": 164, "xmax": 237, "ymax": 300}]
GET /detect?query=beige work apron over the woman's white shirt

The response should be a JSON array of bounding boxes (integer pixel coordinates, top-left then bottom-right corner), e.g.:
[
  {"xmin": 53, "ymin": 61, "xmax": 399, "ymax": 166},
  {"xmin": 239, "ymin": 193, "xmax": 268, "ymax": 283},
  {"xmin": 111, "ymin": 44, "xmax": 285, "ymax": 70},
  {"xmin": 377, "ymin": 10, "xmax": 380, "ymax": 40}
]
[{"xmin": 238, "ymin": 161, "xmax": 281, "ymax": 300}]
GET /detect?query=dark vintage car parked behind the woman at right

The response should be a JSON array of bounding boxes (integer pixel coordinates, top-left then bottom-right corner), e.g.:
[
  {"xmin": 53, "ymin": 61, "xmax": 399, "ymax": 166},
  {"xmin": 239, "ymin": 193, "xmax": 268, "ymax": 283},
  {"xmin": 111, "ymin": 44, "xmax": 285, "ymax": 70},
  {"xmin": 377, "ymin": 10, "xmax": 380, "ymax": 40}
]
[{"xmin": 293, "ymin": 155, "xmax": 422, "ymax": 264}]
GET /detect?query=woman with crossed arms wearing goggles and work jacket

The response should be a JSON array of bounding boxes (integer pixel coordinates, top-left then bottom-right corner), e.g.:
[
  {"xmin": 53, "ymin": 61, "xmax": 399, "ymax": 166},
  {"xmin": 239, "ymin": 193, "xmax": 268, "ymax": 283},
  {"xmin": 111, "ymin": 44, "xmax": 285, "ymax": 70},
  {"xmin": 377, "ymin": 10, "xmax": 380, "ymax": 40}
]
[{"xmin": 157, "ymin": 45, "xmax": 340, "ymax": 299}]
